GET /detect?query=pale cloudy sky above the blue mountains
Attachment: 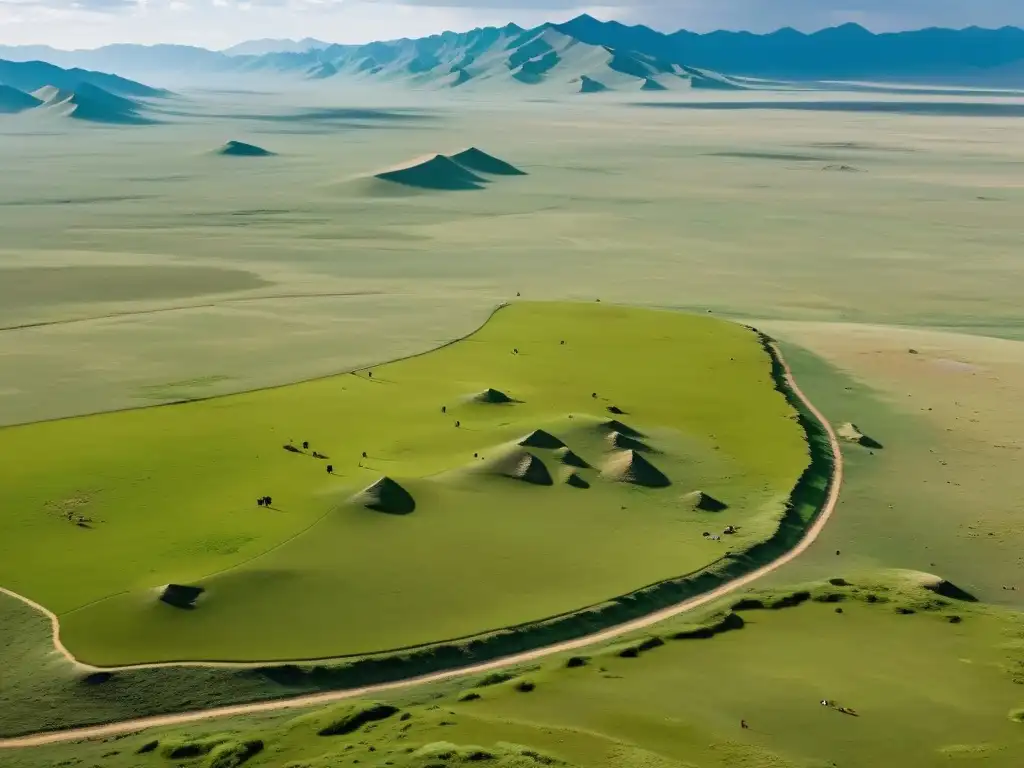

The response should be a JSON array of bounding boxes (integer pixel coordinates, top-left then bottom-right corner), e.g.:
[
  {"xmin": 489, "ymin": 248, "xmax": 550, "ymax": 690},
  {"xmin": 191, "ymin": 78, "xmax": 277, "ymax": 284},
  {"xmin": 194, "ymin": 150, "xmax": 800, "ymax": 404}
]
[{"xmin": 6, "ymin": 0, "xmax": 1024, "ymax": 48}]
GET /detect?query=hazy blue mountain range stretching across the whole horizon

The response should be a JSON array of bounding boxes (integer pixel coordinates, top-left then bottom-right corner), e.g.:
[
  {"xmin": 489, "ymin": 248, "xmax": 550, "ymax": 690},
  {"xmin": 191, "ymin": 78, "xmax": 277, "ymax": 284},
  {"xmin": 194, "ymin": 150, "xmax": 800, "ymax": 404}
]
[{"xmin": 0, "ymin": 15, "xmax": 1024, "ymax": 90}]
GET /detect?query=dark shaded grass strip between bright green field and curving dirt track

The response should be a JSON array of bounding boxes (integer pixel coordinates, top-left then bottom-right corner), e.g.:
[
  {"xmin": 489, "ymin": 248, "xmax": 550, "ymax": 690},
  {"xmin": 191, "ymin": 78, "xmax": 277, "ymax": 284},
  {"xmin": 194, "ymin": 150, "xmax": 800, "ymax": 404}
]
[{"xmin": 0, "ymin": 329, "xmax": 834, "ymax": 736}]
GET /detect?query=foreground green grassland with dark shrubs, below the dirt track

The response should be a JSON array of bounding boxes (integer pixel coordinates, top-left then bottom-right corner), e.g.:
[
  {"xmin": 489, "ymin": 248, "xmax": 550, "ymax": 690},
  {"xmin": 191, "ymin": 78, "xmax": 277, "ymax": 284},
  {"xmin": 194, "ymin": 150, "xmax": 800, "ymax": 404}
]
[{"xmin": 4, "ymin": 572, "xmax": 1024, "ymax": 768}]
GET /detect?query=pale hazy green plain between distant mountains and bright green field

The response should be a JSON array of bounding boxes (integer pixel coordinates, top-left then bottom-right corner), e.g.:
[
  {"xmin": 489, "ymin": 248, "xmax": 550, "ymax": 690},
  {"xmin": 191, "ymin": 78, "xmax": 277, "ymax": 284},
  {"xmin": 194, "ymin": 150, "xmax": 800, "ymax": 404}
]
[{"xmin": 0, "ymin": 91, "xmax": 1024, "ymax": 423}]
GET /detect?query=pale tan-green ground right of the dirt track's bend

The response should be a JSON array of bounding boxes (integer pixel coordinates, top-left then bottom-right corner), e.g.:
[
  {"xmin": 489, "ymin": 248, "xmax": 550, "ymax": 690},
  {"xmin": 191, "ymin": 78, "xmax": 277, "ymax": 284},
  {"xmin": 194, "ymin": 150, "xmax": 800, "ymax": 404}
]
[{"xmin": 763, "ymin": 322, "xmax": 1024, "ymax": 609}]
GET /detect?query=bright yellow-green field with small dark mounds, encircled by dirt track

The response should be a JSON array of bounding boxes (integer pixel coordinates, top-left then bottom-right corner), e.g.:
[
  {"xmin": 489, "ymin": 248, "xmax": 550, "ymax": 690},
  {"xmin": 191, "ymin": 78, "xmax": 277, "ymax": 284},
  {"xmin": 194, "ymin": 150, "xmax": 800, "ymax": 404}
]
[{"xmin": 0, "ymin": 303, "xmax": 808, "ymax": 665}]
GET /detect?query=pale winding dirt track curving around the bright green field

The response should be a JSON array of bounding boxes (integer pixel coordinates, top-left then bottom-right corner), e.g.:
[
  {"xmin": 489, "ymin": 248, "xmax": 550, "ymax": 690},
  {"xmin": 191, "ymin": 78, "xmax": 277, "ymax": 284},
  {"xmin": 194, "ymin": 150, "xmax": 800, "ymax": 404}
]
[{"xmin": 0, "ymin": 343, "xmax": 843, "ymax": 749}]
